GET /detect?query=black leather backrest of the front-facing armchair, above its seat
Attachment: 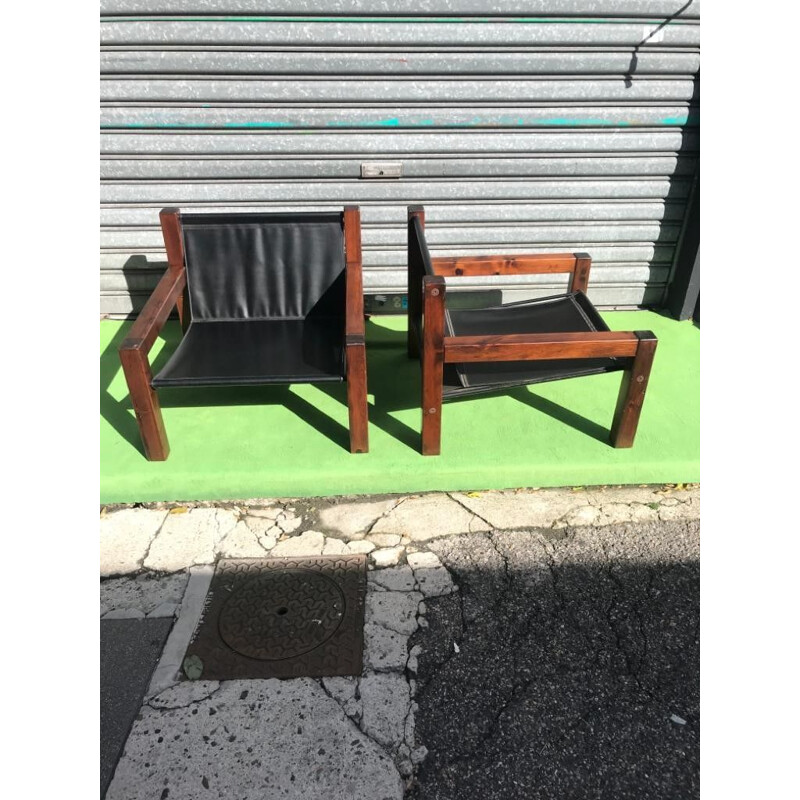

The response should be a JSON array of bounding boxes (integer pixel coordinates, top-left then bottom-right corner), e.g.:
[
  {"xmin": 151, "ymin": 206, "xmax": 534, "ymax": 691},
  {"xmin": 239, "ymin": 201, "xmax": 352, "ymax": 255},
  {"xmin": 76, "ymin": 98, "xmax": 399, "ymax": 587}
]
[{"xmin": 181, "ymin": 213, "xmax": 345, "ymax": 320}]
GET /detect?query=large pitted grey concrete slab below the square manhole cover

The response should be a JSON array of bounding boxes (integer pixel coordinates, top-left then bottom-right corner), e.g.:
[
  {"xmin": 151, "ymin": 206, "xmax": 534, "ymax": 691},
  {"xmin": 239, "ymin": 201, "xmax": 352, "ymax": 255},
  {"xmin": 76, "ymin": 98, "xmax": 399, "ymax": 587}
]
[{"xmin": 106, "ymin": 678, "xmax": 404, "ymax": 800}]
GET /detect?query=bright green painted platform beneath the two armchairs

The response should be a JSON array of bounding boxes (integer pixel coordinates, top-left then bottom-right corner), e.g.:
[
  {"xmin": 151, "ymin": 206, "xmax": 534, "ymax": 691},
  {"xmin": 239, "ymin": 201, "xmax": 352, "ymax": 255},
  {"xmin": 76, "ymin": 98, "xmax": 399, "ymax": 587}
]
[{"xmin": 100, "ymin": 311, "xmax": 700, "ymax": 503}]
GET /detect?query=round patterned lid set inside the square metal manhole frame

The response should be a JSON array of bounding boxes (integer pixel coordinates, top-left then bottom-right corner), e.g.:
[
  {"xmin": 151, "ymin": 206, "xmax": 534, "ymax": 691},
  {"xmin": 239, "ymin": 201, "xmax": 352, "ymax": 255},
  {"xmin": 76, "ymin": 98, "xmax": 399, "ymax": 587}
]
[{"xmin": 219, "ymin": 569, "xmax": 344, "ymax": 661}]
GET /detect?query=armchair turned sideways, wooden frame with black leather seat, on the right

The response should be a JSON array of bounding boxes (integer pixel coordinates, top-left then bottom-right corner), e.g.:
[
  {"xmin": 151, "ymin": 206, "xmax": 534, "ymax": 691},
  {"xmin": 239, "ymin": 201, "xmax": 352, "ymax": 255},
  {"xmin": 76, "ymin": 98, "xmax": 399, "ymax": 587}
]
[{"xmin": 408, "ymin": 206, "xmax": 657, "ymax": 455}]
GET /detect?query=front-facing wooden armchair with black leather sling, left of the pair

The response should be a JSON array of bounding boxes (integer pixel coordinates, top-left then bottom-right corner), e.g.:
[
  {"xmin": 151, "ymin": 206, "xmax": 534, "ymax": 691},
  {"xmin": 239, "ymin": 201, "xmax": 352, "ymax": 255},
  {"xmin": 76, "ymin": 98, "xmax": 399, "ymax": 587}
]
[{"xmin": 119, "ymin": 206, "xmax": 369, "ymax": 461}]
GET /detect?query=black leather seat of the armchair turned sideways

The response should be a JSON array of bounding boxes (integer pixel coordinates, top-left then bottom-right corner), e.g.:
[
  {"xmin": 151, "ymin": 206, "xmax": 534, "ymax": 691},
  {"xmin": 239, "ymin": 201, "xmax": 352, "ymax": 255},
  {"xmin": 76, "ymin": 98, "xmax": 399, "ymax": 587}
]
[{"xmin": 443, "ymin": 292, "xmax": 625, "ymax": 398}]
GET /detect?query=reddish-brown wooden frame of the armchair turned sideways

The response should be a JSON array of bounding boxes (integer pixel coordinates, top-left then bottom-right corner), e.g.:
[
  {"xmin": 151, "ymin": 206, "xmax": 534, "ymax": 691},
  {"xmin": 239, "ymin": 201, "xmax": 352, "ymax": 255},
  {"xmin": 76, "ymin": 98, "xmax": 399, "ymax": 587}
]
[{"xmin": 408, "ymin": 206, "xmax": 657, "ymax": 455}]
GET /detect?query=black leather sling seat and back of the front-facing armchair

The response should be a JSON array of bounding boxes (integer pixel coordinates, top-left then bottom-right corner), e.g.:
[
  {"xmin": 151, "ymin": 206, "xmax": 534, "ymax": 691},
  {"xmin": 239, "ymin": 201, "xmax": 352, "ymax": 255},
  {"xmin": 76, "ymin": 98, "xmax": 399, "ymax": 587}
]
[{"xmin": 152, "ymin": 213, "xmax": 345, "ymax": 388}]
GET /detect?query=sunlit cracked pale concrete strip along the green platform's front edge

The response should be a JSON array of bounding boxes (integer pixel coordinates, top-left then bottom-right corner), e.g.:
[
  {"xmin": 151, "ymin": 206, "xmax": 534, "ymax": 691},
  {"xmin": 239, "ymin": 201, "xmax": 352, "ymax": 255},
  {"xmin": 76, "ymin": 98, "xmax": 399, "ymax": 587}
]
[{"xmin": 100, "ymin": 486, "xmax": 700, "ymax": 576}]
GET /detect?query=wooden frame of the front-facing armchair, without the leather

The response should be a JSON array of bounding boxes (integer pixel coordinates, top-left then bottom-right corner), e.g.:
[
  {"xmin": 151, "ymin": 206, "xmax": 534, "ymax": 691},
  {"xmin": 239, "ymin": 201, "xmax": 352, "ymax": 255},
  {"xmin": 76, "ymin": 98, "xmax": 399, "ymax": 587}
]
[{"xmin": 119, "ymin": 206, "xmax": 369, "ymax": 461}]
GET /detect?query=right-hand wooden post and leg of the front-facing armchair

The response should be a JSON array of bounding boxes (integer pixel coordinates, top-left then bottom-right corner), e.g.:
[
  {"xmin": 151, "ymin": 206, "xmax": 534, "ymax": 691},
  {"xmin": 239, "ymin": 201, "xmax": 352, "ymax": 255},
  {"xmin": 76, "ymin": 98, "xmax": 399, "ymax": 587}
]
[{"xmin": 344, "ymin": 206, "xmax": 369, "ymax": 453}]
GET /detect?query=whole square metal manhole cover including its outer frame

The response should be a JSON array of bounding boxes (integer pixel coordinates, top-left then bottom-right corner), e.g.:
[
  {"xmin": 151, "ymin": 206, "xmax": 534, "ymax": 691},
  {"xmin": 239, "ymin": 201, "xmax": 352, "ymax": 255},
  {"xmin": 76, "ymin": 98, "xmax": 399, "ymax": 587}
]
[{"xmin": 184, "ymin": 555, "xmax": 366, "ymax": 680}]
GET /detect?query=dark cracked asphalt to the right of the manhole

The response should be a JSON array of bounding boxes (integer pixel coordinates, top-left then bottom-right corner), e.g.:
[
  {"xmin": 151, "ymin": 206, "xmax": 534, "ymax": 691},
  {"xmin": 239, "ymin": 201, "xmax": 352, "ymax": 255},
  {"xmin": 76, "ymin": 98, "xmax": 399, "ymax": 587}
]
[{"xmin": 408, "ymin": 522, "xmax": 699, "ymax": 800}]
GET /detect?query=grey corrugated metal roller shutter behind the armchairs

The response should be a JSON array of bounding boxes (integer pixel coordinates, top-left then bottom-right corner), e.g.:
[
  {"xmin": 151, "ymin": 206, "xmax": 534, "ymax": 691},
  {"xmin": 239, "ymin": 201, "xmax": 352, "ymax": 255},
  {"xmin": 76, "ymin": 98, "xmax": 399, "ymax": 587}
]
[{"xmin": 100, "ymin": 0, "xmax": 700, "ymax": 314}]
